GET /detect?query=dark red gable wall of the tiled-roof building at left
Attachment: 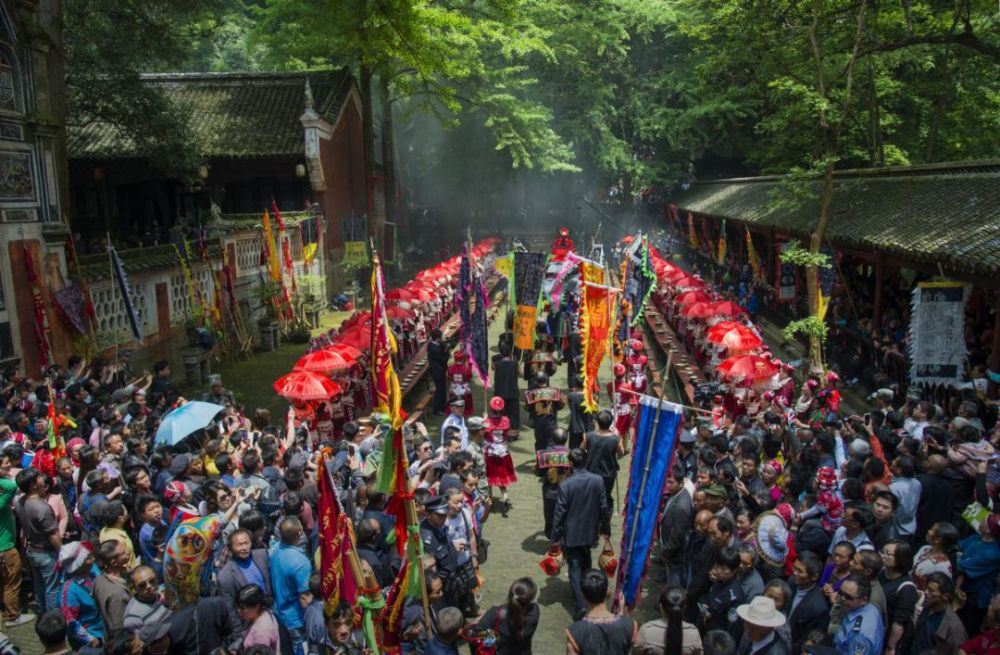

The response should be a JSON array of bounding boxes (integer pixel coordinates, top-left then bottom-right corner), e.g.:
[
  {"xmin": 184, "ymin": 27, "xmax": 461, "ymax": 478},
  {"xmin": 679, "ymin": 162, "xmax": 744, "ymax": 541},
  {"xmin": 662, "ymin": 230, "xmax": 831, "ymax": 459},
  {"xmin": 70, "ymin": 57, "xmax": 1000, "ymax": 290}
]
[{"xmin": 320, "ymin": 98, "xmax": 368, "ymax": 252}]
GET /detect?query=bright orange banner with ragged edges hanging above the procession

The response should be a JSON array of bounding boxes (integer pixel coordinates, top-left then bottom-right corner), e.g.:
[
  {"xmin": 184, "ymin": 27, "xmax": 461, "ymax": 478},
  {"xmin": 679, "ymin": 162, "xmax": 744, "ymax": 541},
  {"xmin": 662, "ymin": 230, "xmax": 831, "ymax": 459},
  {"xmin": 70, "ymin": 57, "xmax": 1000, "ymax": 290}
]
[{"xmin": 580, "ymin": 262, "xmax": 612, "ymax": 412}]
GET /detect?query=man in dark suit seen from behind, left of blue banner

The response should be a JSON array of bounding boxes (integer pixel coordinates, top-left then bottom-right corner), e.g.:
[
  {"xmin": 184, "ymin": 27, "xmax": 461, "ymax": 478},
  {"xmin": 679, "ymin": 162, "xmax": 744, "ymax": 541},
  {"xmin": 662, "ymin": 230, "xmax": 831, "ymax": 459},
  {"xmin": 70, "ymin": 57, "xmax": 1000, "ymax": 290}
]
[{"xmin": 552, "ymin": 448, "xmax": 611, "ymax": 619}]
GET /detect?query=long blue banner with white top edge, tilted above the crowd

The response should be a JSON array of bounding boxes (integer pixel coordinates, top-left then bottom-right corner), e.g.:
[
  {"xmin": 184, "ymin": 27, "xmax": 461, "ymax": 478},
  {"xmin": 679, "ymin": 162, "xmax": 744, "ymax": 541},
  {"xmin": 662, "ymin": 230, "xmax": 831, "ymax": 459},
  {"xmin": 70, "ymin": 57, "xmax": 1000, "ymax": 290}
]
[{"xmin": 618, "ymin": 396, "xmax": 683, "ymax": 609}]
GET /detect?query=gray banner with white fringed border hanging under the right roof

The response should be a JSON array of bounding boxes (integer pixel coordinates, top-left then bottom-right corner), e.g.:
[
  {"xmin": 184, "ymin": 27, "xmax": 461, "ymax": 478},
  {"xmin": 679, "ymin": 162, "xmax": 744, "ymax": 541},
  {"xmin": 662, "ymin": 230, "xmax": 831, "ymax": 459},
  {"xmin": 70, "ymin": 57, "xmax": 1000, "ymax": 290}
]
[{"xmin": 910, "ymin": 281, "xmax": 971, "ymax": 386}]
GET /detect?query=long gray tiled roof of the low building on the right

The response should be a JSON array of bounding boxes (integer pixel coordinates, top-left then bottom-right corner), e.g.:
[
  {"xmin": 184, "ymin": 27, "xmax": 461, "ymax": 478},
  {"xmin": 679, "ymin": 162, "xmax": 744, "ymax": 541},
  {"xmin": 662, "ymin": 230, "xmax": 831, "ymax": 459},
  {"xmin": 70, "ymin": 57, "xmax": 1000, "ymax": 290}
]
[{"xmin": 672, "ymin": 161, "xmax": 1000, "ymax": 275}]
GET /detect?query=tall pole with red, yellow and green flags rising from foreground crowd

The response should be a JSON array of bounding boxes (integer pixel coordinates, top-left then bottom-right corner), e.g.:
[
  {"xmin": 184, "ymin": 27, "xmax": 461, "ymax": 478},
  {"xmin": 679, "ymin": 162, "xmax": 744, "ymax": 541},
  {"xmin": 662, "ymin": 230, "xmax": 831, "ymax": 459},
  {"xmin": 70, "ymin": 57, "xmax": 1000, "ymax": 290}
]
[{"xmin": 371, "ymin": 243, "xmax": 432, "ymax": 634}]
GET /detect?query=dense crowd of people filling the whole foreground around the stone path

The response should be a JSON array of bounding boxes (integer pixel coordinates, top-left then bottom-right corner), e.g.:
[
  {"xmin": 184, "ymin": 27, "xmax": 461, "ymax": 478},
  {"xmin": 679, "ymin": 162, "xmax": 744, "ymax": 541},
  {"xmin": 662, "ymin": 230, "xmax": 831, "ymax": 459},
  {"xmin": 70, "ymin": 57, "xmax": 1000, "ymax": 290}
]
[{"xmin": 0, "ymin": 229, "xmax": 1000, "ymax": 655}]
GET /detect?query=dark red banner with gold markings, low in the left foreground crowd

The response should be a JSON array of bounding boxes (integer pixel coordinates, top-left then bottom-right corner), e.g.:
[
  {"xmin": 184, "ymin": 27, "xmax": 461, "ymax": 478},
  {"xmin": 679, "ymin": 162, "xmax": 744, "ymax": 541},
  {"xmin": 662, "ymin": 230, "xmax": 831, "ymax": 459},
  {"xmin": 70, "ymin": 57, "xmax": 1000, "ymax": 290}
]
[{"xmin": 316, "ymin": 460, "xmax": 358, "ymax": 616}]
